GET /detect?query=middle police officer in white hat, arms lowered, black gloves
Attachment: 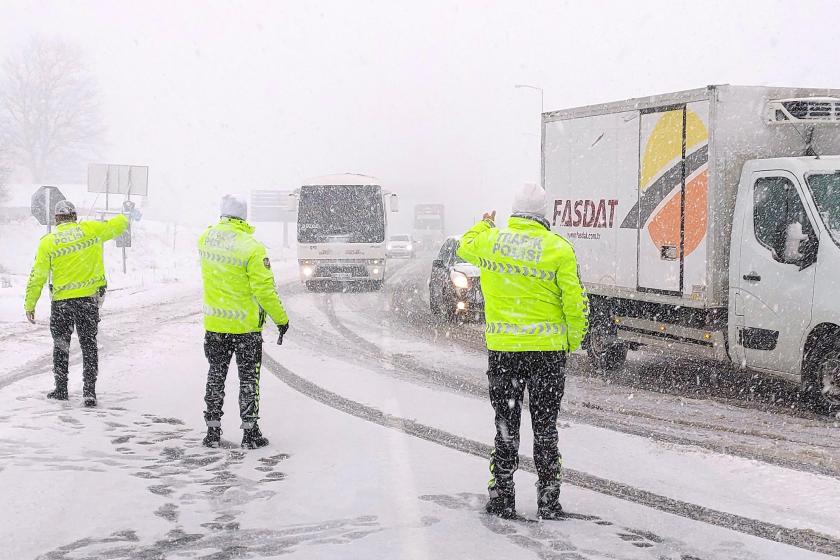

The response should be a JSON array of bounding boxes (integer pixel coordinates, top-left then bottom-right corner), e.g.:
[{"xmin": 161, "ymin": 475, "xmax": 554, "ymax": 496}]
[{"xmin": 198, "ymin": 195, "xmax": 289, "ymax": 449}]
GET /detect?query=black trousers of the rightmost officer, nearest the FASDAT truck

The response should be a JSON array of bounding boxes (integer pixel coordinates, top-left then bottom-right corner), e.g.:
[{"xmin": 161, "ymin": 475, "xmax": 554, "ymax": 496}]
[{"xmin": 487, "ymin": 350, "xmax": 566, "ymax": 494}]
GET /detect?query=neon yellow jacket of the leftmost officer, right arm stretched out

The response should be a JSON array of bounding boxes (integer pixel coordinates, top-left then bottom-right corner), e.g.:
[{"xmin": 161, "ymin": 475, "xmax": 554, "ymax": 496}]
[{"xmin": 23, "ymin": 214, "xmax": 128, "ymax": 311}]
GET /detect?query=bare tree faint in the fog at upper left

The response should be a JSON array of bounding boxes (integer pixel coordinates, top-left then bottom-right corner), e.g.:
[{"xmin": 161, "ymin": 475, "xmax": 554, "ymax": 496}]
[{"xmin": 0, "ymin": 38, "xmax": 104, "ymax": 183}]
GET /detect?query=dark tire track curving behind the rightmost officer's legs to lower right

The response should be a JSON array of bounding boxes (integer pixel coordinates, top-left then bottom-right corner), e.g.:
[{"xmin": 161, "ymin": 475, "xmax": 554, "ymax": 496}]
[{"xmin": 263, "ymin": 352, "xmax": 840, "ymax": 557}]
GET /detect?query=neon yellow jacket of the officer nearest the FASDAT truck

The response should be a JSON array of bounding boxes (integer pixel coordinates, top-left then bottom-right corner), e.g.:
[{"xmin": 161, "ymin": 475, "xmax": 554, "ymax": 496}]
[{"xmin": 458, "ymin": 217, "xmax": 589, "ymax": 352}]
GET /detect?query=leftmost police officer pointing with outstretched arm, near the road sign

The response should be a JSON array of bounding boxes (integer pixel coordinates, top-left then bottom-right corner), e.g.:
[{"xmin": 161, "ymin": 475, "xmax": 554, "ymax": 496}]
[{"xmin": 24, "ymin": 200, "xmax": 130, "ymax": 406}]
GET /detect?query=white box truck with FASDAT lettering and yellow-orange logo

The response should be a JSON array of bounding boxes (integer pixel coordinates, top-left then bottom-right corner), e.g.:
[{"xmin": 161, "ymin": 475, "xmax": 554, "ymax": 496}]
[{"xmin": 542, "ymin": 85, "xmax": 840, "ymax": 408}]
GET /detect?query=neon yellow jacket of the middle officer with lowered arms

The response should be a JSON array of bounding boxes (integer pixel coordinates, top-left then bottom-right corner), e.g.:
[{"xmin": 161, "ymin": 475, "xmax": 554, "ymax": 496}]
[{"xmin": 198, "ymin": 218, "xmax": 289, "ymax": 334}]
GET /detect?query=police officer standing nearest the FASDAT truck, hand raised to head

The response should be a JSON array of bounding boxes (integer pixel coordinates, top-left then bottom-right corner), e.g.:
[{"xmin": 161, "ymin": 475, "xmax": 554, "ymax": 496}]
[{"xmin": 458, "ymin": 183, "xmax": 588, "ymax": 519}]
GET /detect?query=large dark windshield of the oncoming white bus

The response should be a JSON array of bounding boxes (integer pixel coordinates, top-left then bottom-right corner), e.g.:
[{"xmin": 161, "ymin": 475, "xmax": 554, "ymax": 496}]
[{"xmin": 298, "ymin": 185, "xmax": 385, "ymax": 243}]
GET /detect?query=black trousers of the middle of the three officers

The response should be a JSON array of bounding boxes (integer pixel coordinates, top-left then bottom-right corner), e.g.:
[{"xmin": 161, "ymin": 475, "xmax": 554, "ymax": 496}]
[{"xmin": 204, "ymin": 331, "xmax": 262, "ymax": 429}]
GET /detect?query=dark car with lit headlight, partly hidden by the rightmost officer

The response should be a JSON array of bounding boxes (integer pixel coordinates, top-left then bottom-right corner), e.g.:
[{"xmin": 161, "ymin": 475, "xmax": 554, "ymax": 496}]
[{"xmin": 429, "ymin": 237, "xmax": 484, "ymax": 321}]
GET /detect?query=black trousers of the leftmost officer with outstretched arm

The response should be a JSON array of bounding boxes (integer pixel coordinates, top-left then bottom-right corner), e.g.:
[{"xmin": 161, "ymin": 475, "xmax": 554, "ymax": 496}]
[{"xmin": 50, "ymin": 297, "xmax": 99, "ymax": 393}]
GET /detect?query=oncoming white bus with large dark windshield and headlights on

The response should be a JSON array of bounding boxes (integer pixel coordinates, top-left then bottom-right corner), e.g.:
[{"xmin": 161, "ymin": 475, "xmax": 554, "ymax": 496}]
[{"xmin": 297, "ymin": 173, "xmax": 398, "ymax": 289}]
